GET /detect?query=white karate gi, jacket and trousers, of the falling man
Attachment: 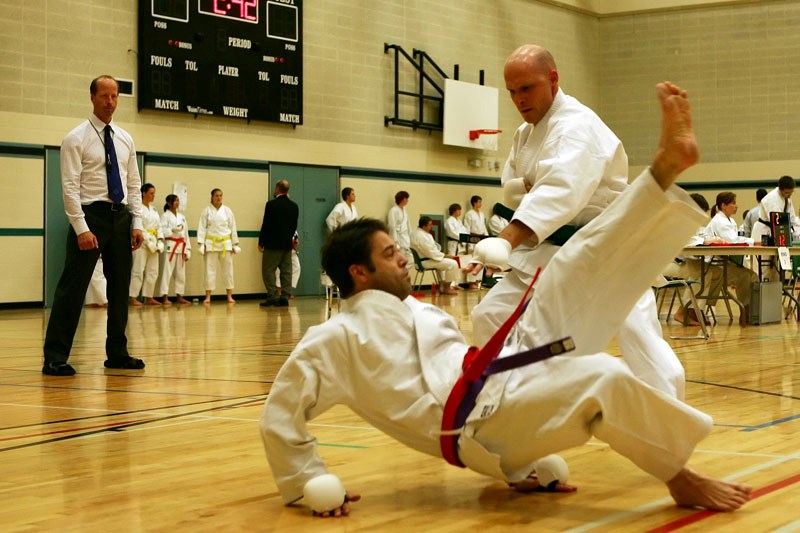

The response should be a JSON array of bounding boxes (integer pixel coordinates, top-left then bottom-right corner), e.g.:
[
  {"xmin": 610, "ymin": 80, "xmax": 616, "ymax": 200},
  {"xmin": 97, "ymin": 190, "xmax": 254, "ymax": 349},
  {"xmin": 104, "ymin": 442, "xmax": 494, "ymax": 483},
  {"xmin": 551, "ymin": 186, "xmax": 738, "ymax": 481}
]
[{"xmin": 260, "ymin": 174, "xmax": 711, "ymax": 504}]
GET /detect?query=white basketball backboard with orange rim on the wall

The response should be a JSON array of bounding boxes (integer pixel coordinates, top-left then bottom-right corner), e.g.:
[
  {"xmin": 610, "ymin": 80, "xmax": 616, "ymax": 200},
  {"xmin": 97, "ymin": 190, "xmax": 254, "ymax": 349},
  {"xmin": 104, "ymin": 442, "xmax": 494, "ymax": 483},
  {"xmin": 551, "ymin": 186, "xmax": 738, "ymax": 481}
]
[{"xmin": 442, "ymin": 78, "xmax": 499, "ymax": 150}]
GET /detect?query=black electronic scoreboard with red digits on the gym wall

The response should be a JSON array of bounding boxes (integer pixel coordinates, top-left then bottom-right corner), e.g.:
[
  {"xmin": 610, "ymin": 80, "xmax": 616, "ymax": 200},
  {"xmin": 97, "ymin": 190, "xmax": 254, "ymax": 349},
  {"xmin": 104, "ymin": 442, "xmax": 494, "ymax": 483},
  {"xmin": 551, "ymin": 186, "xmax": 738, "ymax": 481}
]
[{"xmin": 138, "ymin": 0, "xmax": 303, "ymax": 124}]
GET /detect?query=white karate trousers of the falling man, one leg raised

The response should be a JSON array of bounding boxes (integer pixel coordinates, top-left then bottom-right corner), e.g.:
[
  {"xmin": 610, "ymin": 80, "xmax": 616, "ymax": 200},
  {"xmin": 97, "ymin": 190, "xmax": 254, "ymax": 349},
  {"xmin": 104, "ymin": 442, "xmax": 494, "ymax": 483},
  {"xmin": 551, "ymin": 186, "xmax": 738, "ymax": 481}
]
[{"xmin": 459, "ymin": 175, "xmax": 712, "ymax": 481}]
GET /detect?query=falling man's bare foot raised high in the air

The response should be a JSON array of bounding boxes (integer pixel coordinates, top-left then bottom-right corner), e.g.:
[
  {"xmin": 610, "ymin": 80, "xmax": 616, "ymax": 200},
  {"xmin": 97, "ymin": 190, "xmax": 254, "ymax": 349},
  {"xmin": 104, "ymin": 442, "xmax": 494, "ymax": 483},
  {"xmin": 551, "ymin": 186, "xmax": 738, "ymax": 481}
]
[{"xmin": 650, "ymin": 81, "xmax": 700, "ymax": 190}]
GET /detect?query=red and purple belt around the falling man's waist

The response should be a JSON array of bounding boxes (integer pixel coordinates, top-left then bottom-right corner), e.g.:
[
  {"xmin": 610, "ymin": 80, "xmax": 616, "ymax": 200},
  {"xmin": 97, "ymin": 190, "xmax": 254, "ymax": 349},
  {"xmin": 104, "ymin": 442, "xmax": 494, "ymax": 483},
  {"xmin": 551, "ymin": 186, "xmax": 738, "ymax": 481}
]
[{"xmin": 439, "ymin": 268, "xmax": 575, "ymax": 468}]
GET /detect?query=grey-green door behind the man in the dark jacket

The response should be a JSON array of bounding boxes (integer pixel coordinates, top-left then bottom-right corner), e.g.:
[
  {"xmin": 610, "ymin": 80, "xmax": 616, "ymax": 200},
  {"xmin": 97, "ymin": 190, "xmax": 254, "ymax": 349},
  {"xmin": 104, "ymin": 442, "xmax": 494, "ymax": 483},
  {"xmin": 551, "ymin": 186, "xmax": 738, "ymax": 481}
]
[{"xmin": 269, "ymin": 164, "xmax": 339, "ymax": 296}]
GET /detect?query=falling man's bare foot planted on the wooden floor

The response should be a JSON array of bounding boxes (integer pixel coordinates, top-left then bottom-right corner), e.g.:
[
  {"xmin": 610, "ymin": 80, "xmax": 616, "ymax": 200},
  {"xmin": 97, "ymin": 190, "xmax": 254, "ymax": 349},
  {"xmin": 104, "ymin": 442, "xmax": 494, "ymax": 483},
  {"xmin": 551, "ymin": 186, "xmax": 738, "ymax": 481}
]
[{"xmin": 667, "ymin": 467, "xmax": 753, "ymax": 511}]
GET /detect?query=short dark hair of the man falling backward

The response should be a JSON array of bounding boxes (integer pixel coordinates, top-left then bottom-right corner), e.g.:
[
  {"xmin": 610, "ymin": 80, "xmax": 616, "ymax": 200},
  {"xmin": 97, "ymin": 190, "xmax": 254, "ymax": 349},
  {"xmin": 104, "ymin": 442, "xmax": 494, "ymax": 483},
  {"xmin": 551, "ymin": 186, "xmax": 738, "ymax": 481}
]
[{"xmin": 322, "ymin": 217, "xmax": 389, "ymax": 298}]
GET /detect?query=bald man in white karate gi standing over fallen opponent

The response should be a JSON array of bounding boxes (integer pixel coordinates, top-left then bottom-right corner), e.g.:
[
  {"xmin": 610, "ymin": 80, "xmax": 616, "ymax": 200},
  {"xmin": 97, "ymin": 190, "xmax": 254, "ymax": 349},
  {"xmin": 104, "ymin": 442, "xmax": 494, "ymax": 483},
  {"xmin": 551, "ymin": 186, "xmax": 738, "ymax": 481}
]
[{"xmin": 472, "ymin": 44, "xmax": 684, "ymax": 399}]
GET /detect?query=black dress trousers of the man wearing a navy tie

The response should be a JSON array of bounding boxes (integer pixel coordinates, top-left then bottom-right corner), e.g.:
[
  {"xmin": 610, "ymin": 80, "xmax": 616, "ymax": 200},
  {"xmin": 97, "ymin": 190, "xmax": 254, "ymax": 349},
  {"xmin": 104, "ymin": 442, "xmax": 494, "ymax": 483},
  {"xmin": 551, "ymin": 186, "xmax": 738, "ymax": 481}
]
[{"xmin": 44, "ymin": 202, "xmax": 133, "ymax": 363}]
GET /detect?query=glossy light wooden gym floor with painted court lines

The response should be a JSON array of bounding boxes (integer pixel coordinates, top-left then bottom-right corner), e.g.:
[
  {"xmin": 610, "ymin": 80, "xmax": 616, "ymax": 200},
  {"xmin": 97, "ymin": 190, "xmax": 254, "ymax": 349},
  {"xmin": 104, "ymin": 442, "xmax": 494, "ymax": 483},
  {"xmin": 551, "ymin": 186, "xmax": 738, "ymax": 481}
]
[{"xmin": 0, "ymin": 291, "xmax": 800, "ymax": 533}]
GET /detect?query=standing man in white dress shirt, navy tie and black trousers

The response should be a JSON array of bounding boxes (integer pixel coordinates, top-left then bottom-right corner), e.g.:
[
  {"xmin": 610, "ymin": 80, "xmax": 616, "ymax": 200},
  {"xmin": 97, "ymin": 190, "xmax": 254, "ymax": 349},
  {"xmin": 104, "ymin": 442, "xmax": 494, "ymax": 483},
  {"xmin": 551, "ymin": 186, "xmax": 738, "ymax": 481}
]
[{"xmin": 42, "ymin": 76, "xmax": 144, "ymax": 376}]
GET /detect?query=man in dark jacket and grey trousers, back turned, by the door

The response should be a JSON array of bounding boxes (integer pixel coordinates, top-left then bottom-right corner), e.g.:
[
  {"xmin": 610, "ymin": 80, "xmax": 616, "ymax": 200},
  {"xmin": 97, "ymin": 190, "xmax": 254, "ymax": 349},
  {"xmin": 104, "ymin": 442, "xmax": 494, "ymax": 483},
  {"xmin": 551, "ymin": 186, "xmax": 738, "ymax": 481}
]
[{"xmin": 258, "ymin": 180, "xmax": 300, "ymax": 307}]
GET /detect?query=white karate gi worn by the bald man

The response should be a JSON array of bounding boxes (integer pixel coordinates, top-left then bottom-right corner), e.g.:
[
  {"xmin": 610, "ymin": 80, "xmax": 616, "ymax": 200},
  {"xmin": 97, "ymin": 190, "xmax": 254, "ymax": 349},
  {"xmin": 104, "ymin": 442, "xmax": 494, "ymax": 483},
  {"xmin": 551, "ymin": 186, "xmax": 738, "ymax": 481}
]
[{"xmin": 472, "ymin": 89, "xmax": 685, "ymax": 398}]
